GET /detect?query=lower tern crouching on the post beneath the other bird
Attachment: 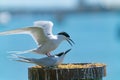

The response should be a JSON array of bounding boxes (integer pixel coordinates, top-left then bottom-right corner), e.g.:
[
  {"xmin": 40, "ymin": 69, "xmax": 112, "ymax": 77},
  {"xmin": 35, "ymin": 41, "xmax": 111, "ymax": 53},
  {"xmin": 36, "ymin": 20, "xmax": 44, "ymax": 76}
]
[{"xmin": 13, "ymin": 49, "xmax": 71, "ymax": 67}]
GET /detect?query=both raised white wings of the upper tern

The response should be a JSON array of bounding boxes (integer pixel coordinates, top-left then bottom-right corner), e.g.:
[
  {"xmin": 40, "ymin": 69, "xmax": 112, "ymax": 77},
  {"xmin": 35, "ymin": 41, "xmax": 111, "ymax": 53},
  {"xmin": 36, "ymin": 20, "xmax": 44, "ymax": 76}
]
[{"xmin": 0, "ymin": 21, "xmax": 53, "ymax": 45}]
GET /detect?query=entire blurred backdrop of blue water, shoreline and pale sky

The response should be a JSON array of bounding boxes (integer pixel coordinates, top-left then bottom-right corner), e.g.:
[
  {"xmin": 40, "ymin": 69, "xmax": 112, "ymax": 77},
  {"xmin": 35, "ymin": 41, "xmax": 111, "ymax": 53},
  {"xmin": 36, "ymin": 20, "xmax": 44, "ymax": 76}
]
[{"xmin": 0, "ymin": 0, "xmax": 120, "ymax": 80}]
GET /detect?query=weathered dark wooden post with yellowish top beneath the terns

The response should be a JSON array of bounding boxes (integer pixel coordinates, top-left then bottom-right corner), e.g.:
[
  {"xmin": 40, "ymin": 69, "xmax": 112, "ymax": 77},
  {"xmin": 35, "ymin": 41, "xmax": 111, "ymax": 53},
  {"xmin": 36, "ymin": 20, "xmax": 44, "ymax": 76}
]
[{"xmin": 28, "ymin": 63, "xmax": 106, "ymax": 80}]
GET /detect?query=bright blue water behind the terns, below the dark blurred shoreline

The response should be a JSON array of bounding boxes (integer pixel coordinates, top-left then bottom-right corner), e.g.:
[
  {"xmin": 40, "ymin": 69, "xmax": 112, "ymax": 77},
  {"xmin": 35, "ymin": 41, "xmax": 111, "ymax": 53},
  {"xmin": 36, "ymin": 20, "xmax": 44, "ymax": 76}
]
[{"xmin": 0, "ymin": 12, "xmax": 120, "ymax": 80}]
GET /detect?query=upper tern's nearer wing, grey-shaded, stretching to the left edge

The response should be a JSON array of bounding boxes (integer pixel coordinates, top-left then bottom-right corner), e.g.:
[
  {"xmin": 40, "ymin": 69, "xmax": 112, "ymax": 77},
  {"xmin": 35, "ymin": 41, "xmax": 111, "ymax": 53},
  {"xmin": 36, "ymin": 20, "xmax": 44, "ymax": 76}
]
[{"xmin": 0, "ymin": 27, "xmax": 47, "ymax": 45}]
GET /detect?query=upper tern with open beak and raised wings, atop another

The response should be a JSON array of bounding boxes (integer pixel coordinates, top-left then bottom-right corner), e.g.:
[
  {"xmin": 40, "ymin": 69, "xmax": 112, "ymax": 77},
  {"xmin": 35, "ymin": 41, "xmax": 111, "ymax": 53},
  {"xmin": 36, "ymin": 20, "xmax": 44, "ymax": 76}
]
[{"xmin": 0, "ymin": 21, "xmax": 74, "ymax": 56}]
